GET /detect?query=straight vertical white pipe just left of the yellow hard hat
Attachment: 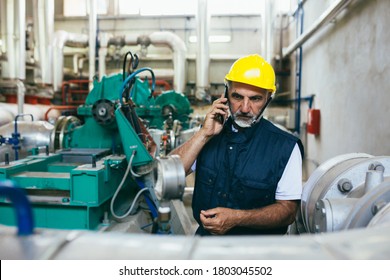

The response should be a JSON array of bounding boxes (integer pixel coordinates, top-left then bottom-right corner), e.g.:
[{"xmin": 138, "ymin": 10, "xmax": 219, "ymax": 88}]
[{"xmin": 195, "ymin": 0, "xmax": 210, "ymax": 100}]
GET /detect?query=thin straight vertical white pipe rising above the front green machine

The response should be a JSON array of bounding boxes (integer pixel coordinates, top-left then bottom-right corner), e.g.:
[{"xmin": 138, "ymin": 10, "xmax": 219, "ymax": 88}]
[{"xmin": 89, "ymin": 0, "xmax": 97, "ymax": 90}]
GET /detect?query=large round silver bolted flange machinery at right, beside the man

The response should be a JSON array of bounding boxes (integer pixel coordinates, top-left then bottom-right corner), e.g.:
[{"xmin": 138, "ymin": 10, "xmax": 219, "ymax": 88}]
[{"xmin": 297, "ymin": 153, "xmax": 390, "ymax": 233}]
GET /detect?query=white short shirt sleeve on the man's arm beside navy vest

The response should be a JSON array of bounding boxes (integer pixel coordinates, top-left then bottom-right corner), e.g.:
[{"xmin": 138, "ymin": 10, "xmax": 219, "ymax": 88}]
[{"xmin": 275, "ymin": 144, "xmax": 302, "ymax": 200}]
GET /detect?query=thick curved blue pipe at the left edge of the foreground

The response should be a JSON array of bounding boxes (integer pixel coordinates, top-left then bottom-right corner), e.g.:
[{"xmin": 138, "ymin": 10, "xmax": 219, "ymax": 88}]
[{"xmin": 0, "ymin": 180, "xmax": 34, "ymax": 236}]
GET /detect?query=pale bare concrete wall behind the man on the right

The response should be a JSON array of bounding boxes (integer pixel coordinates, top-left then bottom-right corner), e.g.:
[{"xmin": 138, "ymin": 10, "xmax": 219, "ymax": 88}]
[{"xmin": 296, "ymin": 0, "xmax": 390, "ymax": 173}]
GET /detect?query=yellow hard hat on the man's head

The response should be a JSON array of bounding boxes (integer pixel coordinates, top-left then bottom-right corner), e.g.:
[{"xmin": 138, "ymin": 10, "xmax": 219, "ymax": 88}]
[{"xmin": 225, "ymin": 54, "xmax": 276, "ymax": 93}]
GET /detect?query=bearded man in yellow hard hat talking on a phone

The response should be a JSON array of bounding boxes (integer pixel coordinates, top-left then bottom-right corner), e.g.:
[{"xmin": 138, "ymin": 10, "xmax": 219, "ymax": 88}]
[{"xmin": 171, "ymin": 55, "xmax": 303, "ymax": 235}]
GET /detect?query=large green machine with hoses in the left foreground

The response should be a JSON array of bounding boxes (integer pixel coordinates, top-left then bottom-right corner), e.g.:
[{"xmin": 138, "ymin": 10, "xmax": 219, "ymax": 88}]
[{"xmin": 0, "ymin": 58, "xmax": 189, "ymax": 230}]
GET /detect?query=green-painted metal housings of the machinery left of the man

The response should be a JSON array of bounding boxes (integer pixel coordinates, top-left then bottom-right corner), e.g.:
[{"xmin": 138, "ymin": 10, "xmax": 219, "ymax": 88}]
[{"xmin": 0, "ymin": 74, "xmax": 191, "ymax": 230}]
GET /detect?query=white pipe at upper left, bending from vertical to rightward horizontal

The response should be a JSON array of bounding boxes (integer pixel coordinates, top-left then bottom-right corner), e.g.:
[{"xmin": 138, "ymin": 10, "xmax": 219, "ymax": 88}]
[{"xmin": 53, "ymin": 30, "xmax": 88, "ymax": 91}]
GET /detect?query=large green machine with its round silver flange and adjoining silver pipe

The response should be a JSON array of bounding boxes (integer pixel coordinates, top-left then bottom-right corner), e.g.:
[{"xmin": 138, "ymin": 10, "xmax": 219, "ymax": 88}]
[{"xmin": 0, "ymin": 52, "xmax": 188, "ymax": 233}]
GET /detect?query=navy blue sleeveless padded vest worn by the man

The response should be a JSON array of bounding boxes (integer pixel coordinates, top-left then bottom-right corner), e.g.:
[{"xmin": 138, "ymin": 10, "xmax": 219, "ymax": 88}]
[{"xmin": 192, "ymin": 118, "xmax": 303, "ymax": 235}]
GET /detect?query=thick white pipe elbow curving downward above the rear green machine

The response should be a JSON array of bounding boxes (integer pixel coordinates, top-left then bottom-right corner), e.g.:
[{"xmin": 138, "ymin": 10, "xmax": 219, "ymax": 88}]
[{"xmin": 149, "ymin": 31, "xmax": 187, "ymax": 92}]
